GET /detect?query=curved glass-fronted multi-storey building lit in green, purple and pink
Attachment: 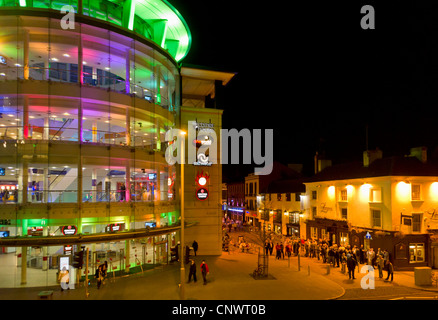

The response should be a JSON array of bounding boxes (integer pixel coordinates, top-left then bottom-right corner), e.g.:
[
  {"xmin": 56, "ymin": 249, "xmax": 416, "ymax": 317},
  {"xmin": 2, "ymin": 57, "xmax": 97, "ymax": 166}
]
[{"xmin": 0, "ymin": 0, "xmax": 233, "ymax": 286}]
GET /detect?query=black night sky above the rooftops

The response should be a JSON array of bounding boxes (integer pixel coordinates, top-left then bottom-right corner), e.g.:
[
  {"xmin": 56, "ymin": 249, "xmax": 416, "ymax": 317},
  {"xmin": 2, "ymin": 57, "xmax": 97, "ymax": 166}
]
[{"xmin": 169, "ymin": 0, "xmax": 438, "ymax": 180}]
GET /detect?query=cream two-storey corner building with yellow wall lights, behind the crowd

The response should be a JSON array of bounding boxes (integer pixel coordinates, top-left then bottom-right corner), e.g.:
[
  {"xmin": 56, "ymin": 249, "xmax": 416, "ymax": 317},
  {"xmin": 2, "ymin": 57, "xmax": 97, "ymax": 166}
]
[{"xmin": 301, "ymin": 148, "xmax": 438, "ymax": 270}]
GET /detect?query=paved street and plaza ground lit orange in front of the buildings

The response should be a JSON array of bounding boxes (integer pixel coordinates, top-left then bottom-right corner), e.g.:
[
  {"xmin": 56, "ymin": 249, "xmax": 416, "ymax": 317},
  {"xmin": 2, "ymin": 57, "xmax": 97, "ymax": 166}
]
[{"xmin": 0, "ymin": 230, "xmax": 438, "ymax": 300}]
